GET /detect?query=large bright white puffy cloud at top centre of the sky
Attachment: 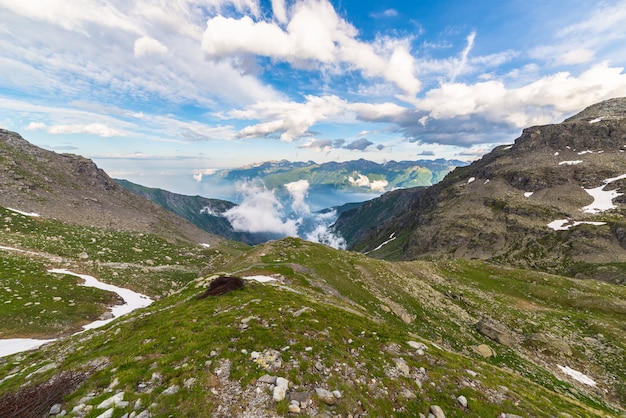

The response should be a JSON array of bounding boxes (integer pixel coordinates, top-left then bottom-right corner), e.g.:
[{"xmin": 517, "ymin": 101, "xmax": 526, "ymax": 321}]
[{"xmin": 202, "ymin": 0, "xmax": 421, "ymax": 96}]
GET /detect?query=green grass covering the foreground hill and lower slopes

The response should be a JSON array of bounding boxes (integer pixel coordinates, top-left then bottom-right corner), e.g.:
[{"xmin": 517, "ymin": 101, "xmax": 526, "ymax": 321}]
[{"xmin": 0, "ymin": 209, "xmax": 626, "ymax": 416}]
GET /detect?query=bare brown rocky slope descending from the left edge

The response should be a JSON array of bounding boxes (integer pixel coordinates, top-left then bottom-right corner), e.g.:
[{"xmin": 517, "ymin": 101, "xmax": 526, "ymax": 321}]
[{"xmin": 0, "ymin": 130, "xmax": 218, "ymax": 243}]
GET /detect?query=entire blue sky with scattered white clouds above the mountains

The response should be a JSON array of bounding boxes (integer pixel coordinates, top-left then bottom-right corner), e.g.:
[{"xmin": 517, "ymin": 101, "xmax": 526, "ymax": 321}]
[{"xmin": 0, "ymin": 0, "xmax": 626, "ymax": 197}]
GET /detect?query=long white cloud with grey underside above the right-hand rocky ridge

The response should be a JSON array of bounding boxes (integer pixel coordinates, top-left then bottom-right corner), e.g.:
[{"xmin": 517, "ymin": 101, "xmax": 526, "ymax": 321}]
[{"xmin": 394, "ymin": 62, "xmax": 626, "ymax": 146}]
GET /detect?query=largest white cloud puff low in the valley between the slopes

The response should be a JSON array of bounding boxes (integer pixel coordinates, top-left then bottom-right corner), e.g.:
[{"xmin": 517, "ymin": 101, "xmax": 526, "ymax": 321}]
[{"xmin": 223, "ymin": 183, "xmax": 298, "ymax": 236}]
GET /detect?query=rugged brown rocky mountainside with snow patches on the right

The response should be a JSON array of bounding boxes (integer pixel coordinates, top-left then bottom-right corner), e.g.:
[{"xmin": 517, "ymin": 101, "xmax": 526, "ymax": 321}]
[{"xmin": 335, "ymin": 98, "xmax": 626, "ymax": 282}]
